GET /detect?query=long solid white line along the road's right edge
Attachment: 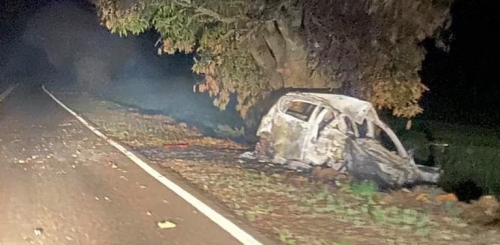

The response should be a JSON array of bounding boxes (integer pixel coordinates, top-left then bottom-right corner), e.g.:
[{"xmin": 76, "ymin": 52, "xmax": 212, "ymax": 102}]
[{"xmin": 42, "ymin": 86, "xmax": 262, "ymax": 245}]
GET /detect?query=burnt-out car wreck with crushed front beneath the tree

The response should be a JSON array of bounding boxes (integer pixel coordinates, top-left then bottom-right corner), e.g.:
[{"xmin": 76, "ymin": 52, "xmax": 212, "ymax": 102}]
[{"xmin": 242, "ymin": 92, "xmax": 440, "ymax": 188}]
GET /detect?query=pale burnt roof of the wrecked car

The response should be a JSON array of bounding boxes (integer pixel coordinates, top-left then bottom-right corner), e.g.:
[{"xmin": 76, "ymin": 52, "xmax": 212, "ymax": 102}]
[{"xmin": 285, "ymin": 92, "xmax": 378, "ymax": 124}]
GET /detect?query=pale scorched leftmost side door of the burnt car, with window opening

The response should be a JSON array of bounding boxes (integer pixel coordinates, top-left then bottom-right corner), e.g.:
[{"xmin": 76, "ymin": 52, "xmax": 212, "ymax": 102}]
[{"xmin": 271, "ymin": 99, "xmax": 317, "ymax": 160}]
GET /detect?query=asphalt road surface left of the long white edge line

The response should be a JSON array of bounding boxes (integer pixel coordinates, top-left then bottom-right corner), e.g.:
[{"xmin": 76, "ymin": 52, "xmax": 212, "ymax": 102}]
[{"xmin": 0, "ymin": 85, "xmax": 252, "ymax": 245}]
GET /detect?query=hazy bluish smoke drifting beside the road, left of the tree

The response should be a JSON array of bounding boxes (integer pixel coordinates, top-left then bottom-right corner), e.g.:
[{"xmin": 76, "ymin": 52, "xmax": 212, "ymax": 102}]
[{"xmin": 13, "ymin": 1, "xmax": 243, "ymax": 138}]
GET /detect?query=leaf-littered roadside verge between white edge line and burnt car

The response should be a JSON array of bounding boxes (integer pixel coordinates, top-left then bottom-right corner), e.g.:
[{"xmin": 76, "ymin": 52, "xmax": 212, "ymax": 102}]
[{"xmin": 55, "ymin": 93, "xmax": 500, "ymax": 245}]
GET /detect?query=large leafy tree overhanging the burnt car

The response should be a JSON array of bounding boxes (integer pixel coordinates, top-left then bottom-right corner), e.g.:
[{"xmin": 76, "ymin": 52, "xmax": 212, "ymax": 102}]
[{"xmin": 94, "ymin": 0, "xmax": 451, "ymax": 117}]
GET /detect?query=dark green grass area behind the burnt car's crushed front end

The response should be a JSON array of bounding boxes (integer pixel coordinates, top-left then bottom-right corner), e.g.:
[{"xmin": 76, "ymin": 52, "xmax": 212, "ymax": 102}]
[{"xmin": 391, "ymin": 120, "xmax": 500, "ymax": 197}]
